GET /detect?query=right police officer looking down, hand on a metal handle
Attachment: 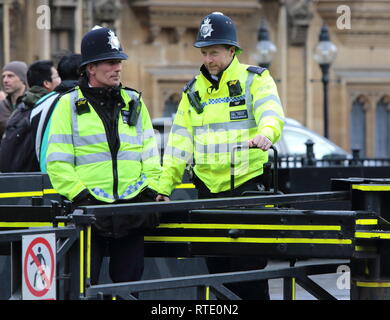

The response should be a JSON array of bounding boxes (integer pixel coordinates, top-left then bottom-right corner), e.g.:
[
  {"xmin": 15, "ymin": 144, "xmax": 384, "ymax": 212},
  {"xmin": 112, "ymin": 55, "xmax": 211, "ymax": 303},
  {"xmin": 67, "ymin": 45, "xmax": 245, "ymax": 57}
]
[{"xmin": 157, "ymin": 12, "xmax": 284, "ymax": 299}]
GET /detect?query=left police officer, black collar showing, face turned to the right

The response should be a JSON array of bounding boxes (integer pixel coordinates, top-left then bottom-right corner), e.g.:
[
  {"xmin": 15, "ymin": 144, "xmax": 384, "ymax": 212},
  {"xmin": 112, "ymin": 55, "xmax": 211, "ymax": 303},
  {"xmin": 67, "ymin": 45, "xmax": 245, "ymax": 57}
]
[{"xmin": 46, "ymin": 27, "xmax": 161, "ymax": 284}]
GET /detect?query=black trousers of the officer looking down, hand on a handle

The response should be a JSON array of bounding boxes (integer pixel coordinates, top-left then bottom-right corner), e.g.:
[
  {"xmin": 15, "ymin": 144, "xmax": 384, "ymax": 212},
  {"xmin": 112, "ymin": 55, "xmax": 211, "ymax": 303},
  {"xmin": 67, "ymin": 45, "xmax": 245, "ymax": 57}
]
[{"xmin": 194, "ymin": 177, "xmax": 270, "ymax": 300}]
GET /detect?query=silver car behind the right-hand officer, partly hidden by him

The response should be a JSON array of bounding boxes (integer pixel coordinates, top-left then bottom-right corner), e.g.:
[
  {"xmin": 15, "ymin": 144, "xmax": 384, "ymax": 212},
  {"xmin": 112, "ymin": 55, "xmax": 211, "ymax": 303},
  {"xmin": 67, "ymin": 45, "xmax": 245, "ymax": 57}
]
[{"xmin": 152, "ymin": 117, "xmax": 352, "ymax": 160}]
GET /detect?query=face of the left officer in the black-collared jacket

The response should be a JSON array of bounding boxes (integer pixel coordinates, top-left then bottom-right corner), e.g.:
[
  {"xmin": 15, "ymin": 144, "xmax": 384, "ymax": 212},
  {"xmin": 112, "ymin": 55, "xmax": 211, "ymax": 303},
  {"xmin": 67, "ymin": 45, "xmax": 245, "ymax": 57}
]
[{"xmin": 87, "ymin": 60, "xmax": 122, "ymax": 87}]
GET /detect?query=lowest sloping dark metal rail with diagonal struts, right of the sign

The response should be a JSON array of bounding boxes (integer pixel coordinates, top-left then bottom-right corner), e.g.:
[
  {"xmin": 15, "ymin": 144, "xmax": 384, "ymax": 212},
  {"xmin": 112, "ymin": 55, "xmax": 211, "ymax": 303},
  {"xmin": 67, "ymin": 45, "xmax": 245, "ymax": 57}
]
[{"xmin": 86, "ymin": 263, "xmax": 346, "ymax": 300}]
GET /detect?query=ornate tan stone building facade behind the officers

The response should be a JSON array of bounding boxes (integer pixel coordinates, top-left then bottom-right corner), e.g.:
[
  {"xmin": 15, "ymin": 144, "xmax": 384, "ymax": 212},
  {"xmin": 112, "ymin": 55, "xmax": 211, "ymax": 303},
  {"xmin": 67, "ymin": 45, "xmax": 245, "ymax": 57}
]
[{"xmin": 0, "ymin": 0, "xmax": 390, "ymax": 157}]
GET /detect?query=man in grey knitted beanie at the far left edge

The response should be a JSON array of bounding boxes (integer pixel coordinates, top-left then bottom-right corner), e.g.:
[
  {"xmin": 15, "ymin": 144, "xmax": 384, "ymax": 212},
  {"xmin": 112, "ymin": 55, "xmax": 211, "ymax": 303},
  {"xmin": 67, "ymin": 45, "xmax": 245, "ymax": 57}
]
[{"xmin": 0, "ymin": 61, "xmax": 27, "ymax": 141}]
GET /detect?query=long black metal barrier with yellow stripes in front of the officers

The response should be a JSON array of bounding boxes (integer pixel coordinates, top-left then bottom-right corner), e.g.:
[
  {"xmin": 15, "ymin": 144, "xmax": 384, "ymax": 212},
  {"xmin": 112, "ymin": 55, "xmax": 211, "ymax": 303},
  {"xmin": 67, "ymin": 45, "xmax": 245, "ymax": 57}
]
[{"xmin": 0, "ymin": 174, "xmax": 390, "ymax": 300}]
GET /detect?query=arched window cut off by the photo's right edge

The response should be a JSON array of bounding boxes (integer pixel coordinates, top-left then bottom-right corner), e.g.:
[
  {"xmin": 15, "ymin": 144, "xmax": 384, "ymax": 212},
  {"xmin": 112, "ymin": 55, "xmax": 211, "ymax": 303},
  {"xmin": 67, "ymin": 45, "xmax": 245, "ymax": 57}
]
[{"xmin": 375, "ymin": 97, "xmax": 390, "ymax": 158}]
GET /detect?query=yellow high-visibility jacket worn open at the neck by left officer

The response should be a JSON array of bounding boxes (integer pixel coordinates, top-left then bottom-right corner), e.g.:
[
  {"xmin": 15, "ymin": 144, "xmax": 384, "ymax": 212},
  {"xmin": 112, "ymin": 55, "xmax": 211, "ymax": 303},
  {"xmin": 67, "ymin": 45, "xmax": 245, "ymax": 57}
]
[{"xmin": 46, "ymin": 87, "xmax": 161, "ymax": 203}]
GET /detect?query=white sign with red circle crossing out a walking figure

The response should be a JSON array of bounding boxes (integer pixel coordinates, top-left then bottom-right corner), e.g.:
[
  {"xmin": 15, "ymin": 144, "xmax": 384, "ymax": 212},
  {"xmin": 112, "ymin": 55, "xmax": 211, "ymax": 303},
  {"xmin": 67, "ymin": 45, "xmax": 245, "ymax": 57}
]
[{"xmin": 22, "ymin": 234, "xmax": 56, "ymax": 300}]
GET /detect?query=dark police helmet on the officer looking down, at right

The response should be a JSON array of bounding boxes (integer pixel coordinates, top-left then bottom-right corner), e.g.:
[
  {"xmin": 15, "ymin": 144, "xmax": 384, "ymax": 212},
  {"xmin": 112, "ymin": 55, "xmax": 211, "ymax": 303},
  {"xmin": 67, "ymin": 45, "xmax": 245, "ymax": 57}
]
[{"xmin": 194, "ymin": 12, "xmax": 242, "ymax": 51}]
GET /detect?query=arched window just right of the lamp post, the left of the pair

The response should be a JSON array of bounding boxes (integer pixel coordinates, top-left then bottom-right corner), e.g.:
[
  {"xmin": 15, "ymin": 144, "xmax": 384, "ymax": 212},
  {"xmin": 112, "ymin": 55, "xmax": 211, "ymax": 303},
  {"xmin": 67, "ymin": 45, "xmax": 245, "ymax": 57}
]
[{"xmin": 350, "ymin": 96, "xmax": 366, "ymax": 157}]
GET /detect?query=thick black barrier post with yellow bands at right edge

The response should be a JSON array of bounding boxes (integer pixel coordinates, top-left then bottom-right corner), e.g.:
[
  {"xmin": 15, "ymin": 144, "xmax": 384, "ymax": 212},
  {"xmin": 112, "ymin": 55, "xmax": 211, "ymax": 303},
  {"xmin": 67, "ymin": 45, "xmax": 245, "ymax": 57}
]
[{"xmin": 334, "ymin": 178, "xmax": 390, "ymax": 300}]
